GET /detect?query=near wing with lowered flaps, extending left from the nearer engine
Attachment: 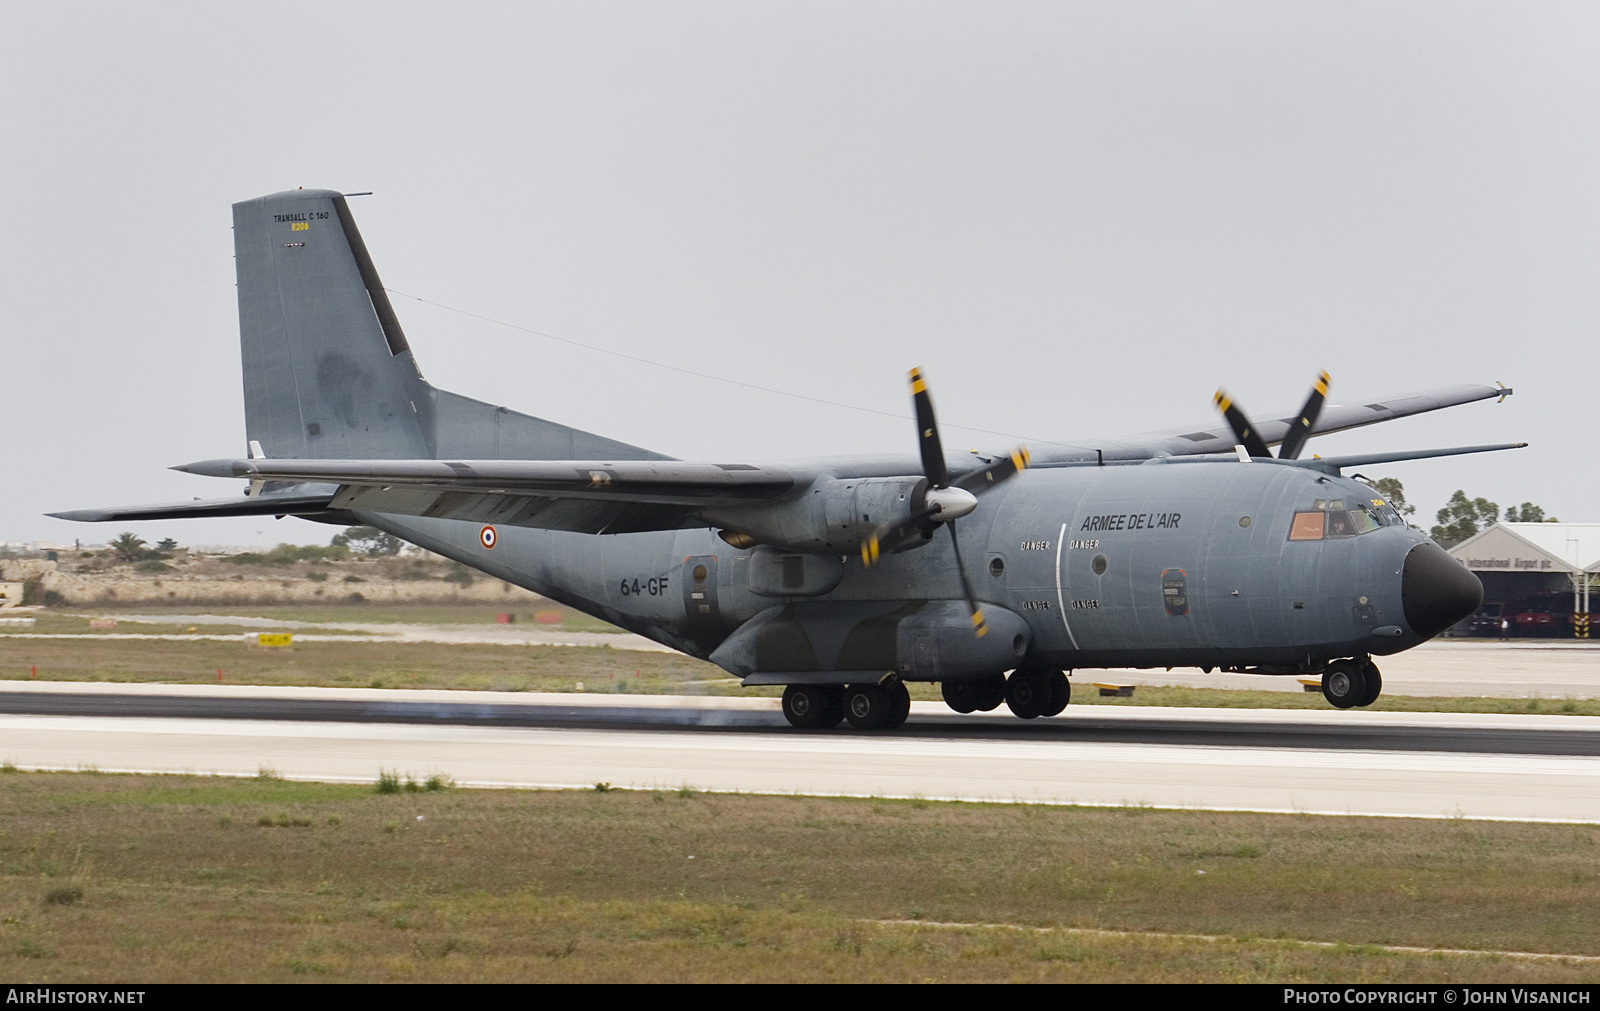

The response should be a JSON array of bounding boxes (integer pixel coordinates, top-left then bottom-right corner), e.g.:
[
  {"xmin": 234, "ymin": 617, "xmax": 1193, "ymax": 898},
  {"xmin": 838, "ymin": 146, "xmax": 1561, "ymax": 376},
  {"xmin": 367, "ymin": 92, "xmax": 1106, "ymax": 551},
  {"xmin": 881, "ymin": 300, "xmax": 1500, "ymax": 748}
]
[{"xmin": 167, "ymin": 459, "xmax": 795, "ymax": 534}]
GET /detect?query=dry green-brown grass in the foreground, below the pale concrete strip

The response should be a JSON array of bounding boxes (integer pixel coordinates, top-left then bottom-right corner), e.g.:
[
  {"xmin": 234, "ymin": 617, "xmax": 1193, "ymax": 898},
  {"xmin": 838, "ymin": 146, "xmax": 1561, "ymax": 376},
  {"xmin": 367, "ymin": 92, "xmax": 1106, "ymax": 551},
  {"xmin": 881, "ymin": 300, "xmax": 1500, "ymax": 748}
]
[{"xmin": 0, "ymin": 773, "xmax": 1600, "ymax": 982}]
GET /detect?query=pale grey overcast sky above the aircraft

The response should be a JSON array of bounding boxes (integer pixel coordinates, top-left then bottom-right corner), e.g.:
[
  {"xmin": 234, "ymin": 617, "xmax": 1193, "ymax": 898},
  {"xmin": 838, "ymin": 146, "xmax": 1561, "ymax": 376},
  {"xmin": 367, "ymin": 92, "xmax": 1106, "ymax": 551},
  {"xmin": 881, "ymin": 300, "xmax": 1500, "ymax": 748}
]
[{"xmin": 0, "ymin": 0, "xmax": 1600, "ymax": 545}]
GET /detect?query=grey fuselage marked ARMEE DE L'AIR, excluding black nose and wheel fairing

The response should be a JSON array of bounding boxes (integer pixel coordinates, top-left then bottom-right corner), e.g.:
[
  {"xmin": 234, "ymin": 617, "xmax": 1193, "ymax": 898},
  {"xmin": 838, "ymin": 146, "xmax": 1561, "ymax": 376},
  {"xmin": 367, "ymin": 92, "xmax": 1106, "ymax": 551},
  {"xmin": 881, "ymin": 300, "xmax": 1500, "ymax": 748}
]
[{"xmin": 362, "ymin": 461, "xmax": 1442, "ymax": 680}]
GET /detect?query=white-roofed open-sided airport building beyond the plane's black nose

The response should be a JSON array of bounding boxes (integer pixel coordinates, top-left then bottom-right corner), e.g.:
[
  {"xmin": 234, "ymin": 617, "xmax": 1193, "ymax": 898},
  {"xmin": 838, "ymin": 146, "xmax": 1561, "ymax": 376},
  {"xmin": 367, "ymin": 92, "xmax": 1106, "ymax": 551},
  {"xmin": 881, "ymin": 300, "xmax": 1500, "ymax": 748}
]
[{"xmin": 1450, "ymin": 523, "xmax": 1600, "ymax": 638}]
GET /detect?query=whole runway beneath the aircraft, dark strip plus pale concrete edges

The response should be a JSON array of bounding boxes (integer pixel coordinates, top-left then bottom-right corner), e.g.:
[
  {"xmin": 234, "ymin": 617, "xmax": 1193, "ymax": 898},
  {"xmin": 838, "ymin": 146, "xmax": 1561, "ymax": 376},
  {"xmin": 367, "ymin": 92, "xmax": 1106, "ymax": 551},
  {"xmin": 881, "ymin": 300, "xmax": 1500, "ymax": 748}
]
[{"xmin": 9, "ymin": 681, "xmax": 1600, "ymax": 822}]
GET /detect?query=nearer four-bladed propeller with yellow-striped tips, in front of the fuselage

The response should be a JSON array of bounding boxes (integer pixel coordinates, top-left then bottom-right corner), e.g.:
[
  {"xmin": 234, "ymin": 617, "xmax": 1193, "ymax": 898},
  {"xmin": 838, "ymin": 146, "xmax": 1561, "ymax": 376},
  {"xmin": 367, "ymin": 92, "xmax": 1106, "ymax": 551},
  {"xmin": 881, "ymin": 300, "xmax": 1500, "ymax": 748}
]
[{"xmin": 861, "ymin": 368, "xmax": 1029, "ymax": 635}]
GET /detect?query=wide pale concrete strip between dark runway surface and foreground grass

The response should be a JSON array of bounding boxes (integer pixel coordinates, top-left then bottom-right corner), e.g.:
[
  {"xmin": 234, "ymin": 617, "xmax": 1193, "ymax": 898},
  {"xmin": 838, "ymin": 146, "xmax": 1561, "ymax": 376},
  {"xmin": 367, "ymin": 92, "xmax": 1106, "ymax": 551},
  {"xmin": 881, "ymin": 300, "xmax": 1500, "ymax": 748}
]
[{"xmin": 0, "ymin": 717, "xmax": 1600, "ymax": 824}]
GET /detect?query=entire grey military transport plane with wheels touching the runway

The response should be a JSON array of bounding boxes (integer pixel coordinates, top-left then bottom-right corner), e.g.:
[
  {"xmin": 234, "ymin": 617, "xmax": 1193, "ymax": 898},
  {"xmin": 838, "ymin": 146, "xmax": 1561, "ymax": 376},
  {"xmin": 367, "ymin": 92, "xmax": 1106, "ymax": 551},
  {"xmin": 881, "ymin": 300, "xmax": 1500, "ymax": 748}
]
[{"xmin": 54, "ymin": 189, "xmax": 1523, "ymax": 729}]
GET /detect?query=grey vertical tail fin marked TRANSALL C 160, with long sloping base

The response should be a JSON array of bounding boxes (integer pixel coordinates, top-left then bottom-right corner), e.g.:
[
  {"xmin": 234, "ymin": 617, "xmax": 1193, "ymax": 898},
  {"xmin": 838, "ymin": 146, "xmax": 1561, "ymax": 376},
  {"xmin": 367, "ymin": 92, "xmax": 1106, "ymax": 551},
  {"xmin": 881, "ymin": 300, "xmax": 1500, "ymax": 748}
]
[{"xmin": 234, "ymin": 189, "xmax": 667, "ymax": 459}]
